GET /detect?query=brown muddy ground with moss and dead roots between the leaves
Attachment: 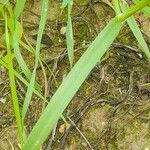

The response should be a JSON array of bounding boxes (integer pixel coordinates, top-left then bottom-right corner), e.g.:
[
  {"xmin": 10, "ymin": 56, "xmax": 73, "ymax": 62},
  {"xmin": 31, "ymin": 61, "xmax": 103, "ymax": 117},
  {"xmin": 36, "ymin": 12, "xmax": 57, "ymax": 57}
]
[{"xmin": 0, "ymin": 0, "xmax": 150, "ymax": 150}]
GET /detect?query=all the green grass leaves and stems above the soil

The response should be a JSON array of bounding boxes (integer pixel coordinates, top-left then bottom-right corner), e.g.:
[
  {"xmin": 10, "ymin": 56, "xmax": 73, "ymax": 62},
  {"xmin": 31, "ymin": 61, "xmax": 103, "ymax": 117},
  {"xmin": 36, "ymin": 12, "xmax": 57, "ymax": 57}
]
[{"xmin": 0, "ymin": 0, "xmax": 150, "ymax": 150}]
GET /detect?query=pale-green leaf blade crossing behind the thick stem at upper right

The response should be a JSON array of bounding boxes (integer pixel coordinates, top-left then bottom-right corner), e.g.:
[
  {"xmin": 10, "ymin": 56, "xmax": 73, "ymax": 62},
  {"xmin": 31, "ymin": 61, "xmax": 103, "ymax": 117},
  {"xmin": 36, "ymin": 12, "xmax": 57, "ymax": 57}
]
[{"xmin": 121, "ymin": 2, "xmax": 150, "ymax": 60}]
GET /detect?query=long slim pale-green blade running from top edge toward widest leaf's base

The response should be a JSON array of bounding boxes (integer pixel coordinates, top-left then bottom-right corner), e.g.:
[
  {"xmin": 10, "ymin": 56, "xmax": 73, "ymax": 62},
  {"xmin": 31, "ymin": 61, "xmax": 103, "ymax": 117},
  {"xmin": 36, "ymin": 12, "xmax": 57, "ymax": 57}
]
[{"xmin": 22, "ymin": 0, "xmax": 49, "ymax": 122}]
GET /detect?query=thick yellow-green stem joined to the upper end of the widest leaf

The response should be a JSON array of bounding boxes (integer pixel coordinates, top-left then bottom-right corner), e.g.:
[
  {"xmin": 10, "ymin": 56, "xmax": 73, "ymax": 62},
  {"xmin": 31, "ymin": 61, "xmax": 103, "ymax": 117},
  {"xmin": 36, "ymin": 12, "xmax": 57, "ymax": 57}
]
[{"xmin": 118, "ymin": 0, "xmax": 150, "ymax": 22}]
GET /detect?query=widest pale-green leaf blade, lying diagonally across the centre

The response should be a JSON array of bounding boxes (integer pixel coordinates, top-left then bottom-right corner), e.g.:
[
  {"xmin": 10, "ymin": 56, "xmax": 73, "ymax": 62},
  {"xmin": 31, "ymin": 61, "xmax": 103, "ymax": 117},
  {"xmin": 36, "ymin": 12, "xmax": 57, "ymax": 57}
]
[{"xmin": 23, "ymin": 18, "xmax": 122, "ymax": 150}]
